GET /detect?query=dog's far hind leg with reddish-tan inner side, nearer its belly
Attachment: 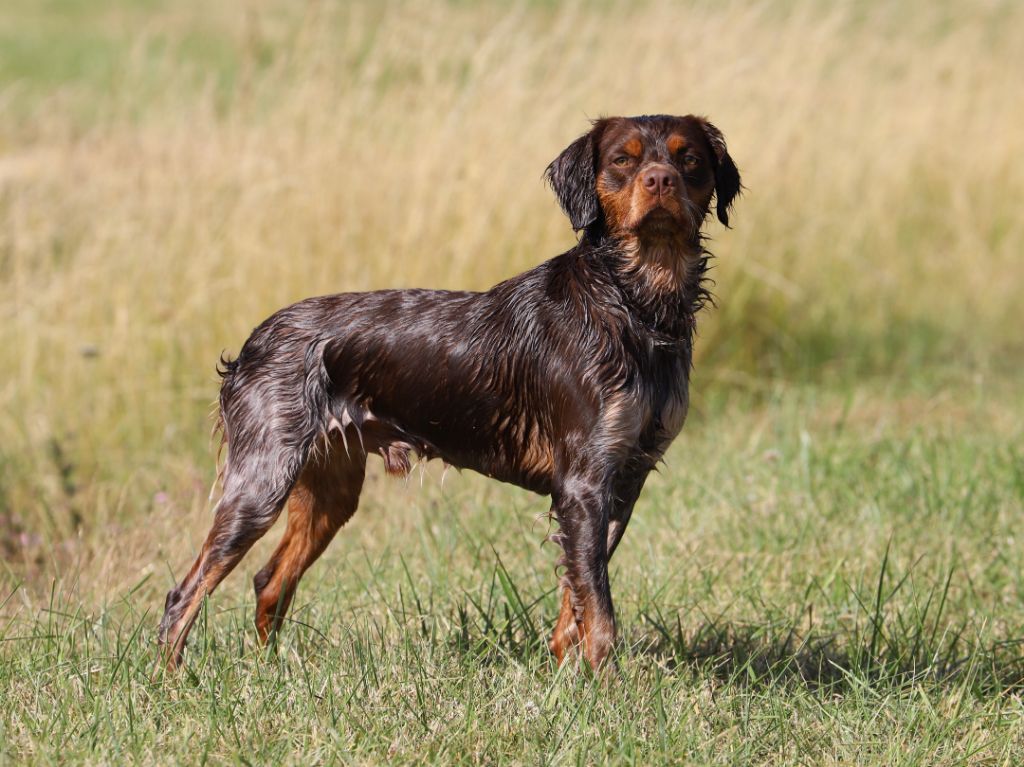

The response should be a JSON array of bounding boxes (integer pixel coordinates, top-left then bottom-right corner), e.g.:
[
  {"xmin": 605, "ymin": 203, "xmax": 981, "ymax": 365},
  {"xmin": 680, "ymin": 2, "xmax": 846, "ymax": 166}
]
[{"xmin": 253, "ymin": 437, "xmax": 367, "ymax": 643}]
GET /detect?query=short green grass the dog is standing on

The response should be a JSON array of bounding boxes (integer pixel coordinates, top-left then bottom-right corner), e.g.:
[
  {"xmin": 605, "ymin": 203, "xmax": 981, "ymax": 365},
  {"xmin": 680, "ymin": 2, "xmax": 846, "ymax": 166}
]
[{"xmin": 0, "ymin": 382, "xmax": 1024, "ymax": 765}]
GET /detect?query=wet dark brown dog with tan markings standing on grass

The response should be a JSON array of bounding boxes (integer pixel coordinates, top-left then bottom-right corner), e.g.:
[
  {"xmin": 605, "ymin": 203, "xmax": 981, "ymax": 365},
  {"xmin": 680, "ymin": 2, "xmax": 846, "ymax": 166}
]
[{"xmin": 160, "ymin": 116, "xmax": 740, "ymax": 668}]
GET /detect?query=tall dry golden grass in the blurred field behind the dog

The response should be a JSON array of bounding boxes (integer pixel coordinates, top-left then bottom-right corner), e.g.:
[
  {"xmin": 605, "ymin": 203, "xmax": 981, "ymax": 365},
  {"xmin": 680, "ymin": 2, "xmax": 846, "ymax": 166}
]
[{"xmin": 0, "ymin": 0, "xmax": 1024, "ymax": 585}]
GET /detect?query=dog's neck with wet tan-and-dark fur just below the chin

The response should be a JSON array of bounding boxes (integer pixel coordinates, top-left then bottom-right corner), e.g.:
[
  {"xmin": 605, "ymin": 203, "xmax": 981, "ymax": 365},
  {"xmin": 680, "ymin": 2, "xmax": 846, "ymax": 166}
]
[{"xmin": 607, "ymin": 231, "xmax": 710, "ymax": 341}]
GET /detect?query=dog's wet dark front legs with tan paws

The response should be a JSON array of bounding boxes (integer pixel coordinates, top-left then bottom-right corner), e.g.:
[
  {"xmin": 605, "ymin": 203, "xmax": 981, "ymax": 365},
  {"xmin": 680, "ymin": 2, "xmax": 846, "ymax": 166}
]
[{"xmin": 551, "ymin": 478, "xmax": 615, "ymax": 670}]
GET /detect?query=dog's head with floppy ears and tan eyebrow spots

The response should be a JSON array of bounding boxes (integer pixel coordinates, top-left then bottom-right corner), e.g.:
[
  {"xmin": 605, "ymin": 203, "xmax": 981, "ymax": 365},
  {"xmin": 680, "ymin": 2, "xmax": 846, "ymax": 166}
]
[{"xmin": 546, "ymin": 115, "xmax": 740, "ymax": 240}]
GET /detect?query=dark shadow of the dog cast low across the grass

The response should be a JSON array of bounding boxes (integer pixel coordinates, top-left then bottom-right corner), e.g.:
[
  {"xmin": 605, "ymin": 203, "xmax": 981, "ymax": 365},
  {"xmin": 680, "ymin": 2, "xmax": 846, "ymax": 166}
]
[{"xmin": 447, "ymin": 593, "xmax": 1024, "ymax": 696}]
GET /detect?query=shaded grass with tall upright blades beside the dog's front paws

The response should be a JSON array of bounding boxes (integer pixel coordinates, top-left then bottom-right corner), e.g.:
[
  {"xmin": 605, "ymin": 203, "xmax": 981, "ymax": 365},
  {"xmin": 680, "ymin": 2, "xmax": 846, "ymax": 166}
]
[{"xmin": 446, "ymin": 551, "xmax": 1024, "ymax": 695}]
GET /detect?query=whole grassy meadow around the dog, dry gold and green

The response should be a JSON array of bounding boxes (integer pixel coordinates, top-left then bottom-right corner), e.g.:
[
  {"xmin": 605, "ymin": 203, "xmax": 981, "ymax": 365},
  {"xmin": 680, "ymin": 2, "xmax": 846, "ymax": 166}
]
[{"xmin": 0, "ymin": 0, "xmax": 1024, "ymax": 765}]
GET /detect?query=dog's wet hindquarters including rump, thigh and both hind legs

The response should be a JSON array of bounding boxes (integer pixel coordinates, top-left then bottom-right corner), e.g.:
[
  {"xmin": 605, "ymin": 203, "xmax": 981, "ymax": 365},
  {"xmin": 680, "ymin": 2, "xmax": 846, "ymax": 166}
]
[{"xmin": 159, "ymin": 309, "xmax": 339, "ymax": 668}]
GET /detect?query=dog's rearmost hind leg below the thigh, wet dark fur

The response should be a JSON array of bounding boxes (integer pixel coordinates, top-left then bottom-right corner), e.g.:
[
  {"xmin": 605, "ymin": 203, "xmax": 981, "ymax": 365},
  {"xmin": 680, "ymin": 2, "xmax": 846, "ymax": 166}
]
[{"xmin": 153, "ymin": 448, "xmax": 298, "ymax": 670}]
